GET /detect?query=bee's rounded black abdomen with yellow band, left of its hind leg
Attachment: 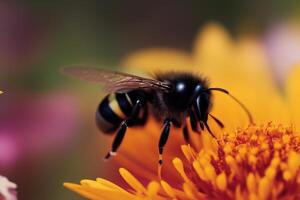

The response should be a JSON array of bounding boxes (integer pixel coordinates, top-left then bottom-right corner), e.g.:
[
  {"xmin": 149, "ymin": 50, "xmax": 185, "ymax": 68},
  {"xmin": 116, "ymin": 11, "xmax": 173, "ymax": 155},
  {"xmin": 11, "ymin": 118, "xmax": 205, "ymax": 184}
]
[{"xmin": 96, "ymin": 93, "xmax": 133, "ymax": 133}]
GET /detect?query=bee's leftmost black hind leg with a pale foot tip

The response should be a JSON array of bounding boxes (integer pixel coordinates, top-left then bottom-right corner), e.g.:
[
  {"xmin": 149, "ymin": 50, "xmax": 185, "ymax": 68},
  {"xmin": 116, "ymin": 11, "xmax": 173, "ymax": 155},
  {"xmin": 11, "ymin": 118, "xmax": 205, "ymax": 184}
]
[{"xmin": 104, "ymin": 100, "xmax": 142, "ymax": 160}]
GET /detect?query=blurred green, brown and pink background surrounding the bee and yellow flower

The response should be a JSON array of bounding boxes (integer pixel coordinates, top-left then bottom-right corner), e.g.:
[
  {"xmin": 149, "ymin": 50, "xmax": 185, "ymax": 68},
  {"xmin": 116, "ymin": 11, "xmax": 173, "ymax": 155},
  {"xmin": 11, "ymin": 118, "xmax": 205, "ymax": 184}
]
[{"xmin": 0, "ymin": 0, "xmax": 300, "ymax": 200}]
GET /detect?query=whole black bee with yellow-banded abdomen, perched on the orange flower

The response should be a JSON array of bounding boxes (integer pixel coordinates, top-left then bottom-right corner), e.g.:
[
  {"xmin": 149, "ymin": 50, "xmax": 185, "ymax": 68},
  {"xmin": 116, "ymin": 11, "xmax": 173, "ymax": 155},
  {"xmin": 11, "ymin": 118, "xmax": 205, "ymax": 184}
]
[{"xmin": 62, "ymin": 66, "xmax": 253, "ymax": 165}]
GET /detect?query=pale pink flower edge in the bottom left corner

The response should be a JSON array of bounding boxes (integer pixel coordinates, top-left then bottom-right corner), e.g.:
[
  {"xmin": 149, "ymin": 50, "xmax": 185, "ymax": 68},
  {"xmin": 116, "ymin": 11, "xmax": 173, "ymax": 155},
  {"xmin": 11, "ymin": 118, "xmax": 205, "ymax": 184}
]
[{"xmin": 0, "ymin": 175, "xmax": 17, "ymax": 200}]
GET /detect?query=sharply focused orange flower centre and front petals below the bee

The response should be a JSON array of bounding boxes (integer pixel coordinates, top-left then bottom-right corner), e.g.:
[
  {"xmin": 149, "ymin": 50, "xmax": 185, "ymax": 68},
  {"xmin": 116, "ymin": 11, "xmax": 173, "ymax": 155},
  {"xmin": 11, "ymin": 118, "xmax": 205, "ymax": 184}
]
[{"xmin": 65, "ymin": 123, "xmax": 300, "ymax": 200}]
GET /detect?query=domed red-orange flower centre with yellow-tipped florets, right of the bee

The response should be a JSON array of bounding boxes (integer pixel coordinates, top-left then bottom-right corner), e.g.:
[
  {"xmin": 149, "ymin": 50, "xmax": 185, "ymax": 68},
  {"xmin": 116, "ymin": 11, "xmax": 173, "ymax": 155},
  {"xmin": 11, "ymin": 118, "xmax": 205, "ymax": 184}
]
[{"xmin": 182, "ymin": 123, "xmax": 300, "ymax": 199}]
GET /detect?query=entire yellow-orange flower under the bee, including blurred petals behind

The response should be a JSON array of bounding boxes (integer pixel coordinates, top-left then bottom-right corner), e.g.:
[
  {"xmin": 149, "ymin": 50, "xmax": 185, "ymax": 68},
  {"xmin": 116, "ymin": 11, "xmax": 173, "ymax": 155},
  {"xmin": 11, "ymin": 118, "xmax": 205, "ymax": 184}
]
[{"xmin": 64, "ymin": 24, "xmax": 300, "ymax": 200}]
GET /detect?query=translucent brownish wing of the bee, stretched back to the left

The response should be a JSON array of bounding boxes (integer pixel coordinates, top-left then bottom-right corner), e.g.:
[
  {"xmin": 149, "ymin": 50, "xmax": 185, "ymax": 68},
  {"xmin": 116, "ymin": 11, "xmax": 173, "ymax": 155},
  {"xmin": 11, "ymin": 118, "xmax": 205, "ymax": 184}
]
[{"xmin": 61, "ymin": 65, "xmax": 170, "ymax": 92}]
